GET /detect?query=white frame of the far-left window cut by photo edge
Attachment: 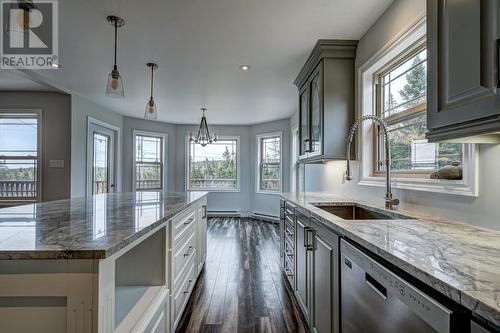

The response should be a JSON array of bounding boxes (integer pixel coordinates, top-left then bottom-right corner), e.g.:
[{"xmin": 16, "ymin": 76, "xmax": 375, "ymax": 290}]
[{"xmin": 0, "ymin": 109, "xmax": 43, "ymax": 206}]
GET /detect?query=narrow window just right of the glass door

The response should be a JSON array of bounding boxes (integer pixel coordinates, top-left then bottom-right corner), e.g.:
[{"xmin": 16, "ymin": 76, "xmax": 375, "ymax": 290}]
[{"xmin": 134, "ymin": 132, "xmax": 166, "ymax": 191}]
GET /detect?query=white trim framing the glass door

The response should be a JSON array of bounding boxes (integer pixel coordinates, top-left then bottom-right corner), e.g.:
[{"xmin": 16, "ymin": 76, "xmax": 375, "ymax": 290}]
[{"xmin": 85, "ymin": 116, "xmax": 122, "ymax": 196}]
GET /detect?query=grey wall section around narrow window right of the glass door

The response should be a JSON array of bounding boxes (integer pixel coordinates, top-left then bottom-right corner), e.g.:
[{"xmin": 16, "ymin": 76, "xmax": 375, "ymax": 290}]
[{"xmin": 122, "ymin": 117, "xmax": 181, "ymax": 192}]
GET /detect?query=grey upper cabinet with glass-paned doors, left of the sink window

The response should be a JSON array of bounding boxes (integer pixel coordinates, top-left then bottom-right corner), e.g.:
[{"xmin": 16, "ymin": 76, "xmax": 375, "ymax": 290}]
[{"xmin": 294, "ymin": 39, "xmax": 357, "ymax": 162}]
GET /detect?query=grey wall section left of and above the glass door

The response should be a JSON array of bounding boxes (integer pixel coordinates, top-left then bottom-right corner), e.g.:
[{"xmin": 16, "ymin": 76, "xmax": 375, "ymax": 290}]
[{"xmin": 71, "ymin": 95, "xmax": 123, "ymax": 197}]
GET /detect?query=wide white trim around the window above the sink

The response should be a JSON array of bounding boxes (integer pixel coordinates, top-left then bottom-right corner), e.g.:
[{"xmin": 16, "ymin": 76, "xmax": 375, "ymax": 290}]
[{"xmin": 357, "ymin": 17, "xmax": 479, "ymax": 197}]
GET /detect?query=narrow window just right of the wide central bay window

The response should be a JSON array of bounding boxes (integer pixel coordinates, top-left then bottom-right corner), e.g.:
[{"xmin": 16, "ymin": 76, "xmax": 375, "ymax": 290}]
[{"xmin": 257, "ymin": 133, "xmax": 281, "ymax": 193}]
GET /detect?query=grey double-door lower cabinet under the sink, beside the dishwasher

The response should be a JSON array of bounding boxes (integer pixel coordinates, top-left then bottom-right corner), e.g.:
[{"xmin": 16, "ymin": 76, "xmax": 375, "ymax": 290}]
[{"xmin": 285, "ymin": 205, "xmax": 340, "ymax": 333}]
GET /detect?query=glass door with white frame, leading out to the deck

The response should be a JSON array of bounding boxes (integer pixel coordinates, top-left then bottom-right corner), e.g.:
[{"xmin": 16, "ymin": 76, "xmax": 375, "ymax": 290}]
[{"xmin": 87, "ymin": 123, "xmax": 117, "ymax": 195}]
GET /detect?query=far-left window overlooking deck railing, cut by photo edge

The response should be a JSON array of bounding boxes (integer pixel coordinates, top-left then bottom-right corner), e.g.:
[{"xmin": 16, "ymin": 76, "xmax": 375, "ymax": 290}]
[{"xmin": 0, "ymin": 113, "xmax": 40, "ymax": 201}]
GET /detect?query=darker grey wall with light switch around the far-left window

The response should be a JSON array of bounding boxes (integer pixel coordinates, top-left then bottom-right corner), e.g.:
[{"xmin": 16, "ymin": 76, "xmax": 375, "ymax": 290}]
[{"xmin": 0, "ymin": 91, "xmax": 72, "ymax": 201}]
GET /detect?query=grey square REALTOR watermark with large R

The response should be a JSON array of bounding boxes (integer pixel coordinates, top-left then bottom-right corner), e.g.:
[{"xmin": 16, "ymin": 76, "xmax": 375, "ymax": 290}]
[{"xmin": 0, "ymin": 0, "xmax": 59, "ymax": 69}]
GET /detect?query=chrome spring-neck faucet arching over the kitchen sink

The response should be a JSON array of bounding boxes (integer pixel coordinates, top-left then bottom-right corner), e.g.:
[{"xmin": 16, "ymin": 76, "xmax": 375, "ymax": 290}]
[{"xmin": 346, "ymin": 115, "xmax": 399, "ymax": 209}]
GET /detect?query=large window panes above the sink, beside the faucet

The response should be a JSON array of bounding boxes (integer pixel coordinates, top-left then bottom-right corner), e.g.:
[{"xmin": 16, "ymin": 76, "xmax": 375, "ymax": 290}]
[{"xmin": 375, "ymin": 41, "xmax": 463, "ymax": 177}]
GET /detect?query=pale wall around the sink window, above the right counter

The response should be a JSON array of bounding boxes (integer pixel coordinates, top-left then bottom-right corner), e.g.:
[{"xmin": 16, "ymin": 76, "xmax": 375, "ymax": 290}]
[{"xmin": 305, "ymin": 0, "xmax": 500, "ymax": 229}]
